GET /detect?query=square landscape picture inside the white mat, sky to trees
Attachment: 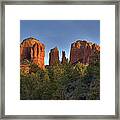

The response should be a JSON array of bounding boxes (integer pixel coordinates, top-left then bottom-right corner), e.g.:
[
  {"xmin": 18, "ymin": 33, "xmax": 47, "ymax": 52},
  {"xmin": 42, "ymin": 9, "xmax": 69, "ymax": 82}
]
[{"xmin": 20, "ymin": 20, "xmax": 100, "ymax": 100}]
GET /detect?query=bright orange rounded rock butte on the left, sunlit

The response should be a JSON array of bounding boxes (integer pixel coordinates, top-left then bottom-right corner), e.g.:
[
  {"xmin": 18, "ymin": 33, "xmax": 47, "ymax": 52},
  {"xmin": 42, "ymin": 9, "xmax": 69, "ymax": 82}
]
[{"xmin": 20, "ymin": 37, "xmax": 45, "ymax": 69}]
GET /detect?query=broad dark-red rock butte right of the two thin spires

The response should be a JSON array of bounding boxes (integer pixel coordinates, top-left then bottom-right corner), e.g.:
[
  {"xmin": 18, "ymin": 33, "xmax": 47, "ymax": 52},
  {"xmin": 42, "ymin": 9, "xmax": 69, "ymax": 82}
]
[{"xmin": 70, "ymin": 40, "xmax": 100, "ymax": 64}]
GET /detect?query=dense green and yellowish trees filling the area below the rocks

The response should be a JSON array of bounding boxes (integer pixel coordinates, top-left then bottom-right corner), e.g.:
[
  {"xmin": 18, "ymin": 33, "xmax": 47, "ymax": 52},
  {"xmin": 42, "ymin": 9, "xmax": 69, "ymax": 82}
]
[{"xmin": 20, "ymin": 55, "xmax": 100, "ymax": 100}]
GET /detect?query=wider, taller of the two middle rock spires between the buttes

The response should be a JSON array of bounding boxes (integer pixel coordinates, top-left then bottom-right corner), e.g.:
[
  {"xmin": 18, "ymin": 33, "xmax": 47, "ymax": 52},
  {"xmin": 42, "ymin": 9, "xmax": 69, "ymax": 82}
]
[{"xmin": 49, "ymin": 47, "xmax": 59, "ymax": 66}]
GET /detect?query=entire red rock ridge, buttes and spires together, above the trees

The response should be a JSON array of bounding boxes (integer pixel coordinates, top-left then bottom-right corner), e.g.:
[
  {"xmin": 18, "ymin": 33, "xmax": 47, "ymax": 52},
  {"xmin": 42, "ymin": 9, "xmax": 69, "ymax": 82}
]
[{"xmin": 20, "ymin": 37, "xmax": 100, "ymax": 69}]
